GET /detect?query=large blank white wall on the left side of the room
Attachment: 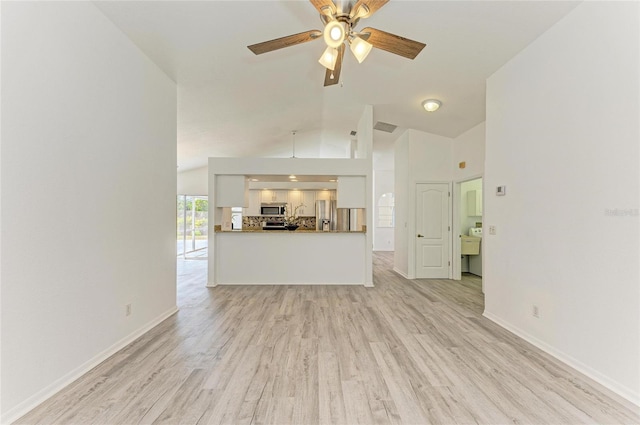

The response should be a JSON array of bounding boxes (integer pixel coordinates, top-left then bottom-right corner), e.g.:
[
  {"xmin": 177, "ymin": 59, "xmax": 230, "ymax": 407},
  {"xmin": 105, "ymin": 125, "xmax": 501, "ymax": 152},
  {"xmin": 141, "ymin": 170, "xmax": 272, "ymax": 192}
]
[{"xmin": 1, "ymin": 2, "xmax": 176, "ymax": 423}]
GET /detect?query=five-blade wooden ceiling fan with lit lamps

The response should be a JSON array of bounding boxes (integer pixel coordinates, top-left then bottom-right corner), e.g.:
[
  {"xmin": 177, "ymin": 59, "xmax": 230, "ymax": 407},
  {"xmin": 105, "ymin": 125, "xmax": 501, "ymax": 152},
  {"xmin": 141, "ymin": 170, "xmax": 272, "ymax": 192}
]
[{"xmin": 247, "ymin": 0, "xmax": 425, "ymax": 87}]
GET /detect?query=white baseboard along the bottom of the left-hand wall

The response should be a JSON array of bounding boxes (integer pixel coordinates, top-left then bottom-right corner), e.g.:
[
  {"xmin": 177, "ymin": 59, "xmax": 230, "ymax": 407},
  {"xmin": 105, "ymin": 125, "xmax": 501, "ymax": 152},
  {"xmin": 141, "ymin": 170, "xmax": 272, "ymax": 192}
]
[{"xmin": 0, "ymin": 306, "xmax": 178, "ymax": 424}]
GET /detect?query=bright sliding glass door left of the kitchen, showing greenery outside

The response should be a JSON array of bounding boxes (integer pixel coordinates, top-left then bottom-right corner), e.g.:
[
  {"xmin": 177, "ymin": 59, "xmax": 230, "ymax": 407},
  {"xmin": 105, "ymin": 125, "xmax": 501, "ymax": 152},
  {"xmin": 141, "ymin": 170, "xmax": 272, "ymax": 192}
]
[{"xmin": 176, "ymin": 195, "xmax": 209, "ymax": 259}]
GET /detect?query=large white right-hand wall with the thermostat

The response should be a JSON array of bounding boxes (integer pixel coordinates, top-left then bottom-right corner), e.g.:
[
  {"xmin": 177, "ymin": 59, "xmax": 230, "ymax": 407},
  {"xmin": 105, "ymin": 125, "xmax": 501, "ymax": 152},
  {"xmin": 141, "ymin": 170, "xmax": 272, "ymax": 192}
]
[{"xmin": 483, "ymin": 2, "xmax": 640, "ymax": 403}]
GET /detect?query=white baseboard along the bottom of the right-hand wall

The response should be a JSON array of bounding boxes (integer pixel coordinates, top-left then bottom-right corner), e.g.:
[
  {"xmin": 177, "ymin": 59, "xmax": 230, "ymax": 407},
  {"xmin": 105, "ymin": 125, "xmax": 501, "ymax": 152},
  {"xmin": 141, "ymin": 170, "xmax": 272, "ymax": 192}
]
[{"xmin": 482, "ymin": 311, "xmax": 640, "ymax": 407}]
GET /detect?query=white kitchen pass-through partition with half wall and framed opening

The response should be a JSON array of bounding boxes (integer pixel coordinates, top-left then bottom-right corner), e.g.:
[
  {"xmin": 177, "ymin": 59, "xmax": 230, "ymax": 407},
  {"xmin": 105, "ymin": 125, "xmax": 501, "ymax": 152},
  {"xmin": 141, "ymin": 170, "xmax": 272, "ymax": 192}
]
[{"xmin": 208, "ymin": 158, "xmax": 373, "ymax": 286}]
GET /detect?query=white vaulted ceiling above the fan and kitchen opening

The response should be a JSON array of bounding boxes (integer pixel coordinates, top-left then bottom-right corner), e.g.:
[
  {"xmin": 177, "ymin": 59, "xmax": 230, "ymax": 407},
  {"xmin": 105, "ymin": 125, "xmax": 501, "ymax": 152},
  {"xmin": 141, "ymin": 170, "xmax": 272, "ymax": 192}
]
[{"xmin": 96, "ymin": 0, "xmax": 578, "ymax": 171}]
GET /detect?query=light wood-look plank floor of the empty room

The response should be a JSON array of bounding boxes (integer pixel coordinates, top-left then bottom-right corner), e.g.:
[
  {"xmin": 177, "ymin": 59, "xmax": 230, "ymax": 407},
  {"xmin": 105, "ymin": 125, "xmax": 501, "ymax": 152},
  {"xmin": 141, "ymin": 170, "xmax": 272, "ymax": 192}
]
[{"xmin": 18, "ymin": 253, "xmax": 640, "ymax": 424}]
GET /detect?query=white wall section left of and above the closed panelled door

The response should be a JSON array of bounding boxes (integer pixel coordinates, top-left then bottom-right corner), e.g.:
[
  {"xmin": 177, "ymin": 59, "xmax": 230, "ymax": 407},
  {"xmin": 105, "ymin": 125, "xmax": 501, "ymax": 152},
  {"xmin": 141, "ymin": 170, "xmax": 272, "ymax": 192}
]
[{"xmin": 394, "ymin": 130, "xmax": 453, "ymax": 279}]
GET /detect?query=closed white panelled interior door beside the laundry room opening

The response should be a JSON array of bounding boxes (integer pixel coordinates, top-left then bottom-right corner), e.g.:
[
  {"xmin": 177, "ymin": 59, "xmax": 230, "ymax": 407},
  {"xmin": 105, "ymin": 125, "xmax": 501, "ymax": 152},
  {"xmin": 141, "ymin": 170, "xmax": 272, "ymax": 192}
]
[{"xmin": 415, "ymin": 183, "xmax": 451, "ymax": 279}]
